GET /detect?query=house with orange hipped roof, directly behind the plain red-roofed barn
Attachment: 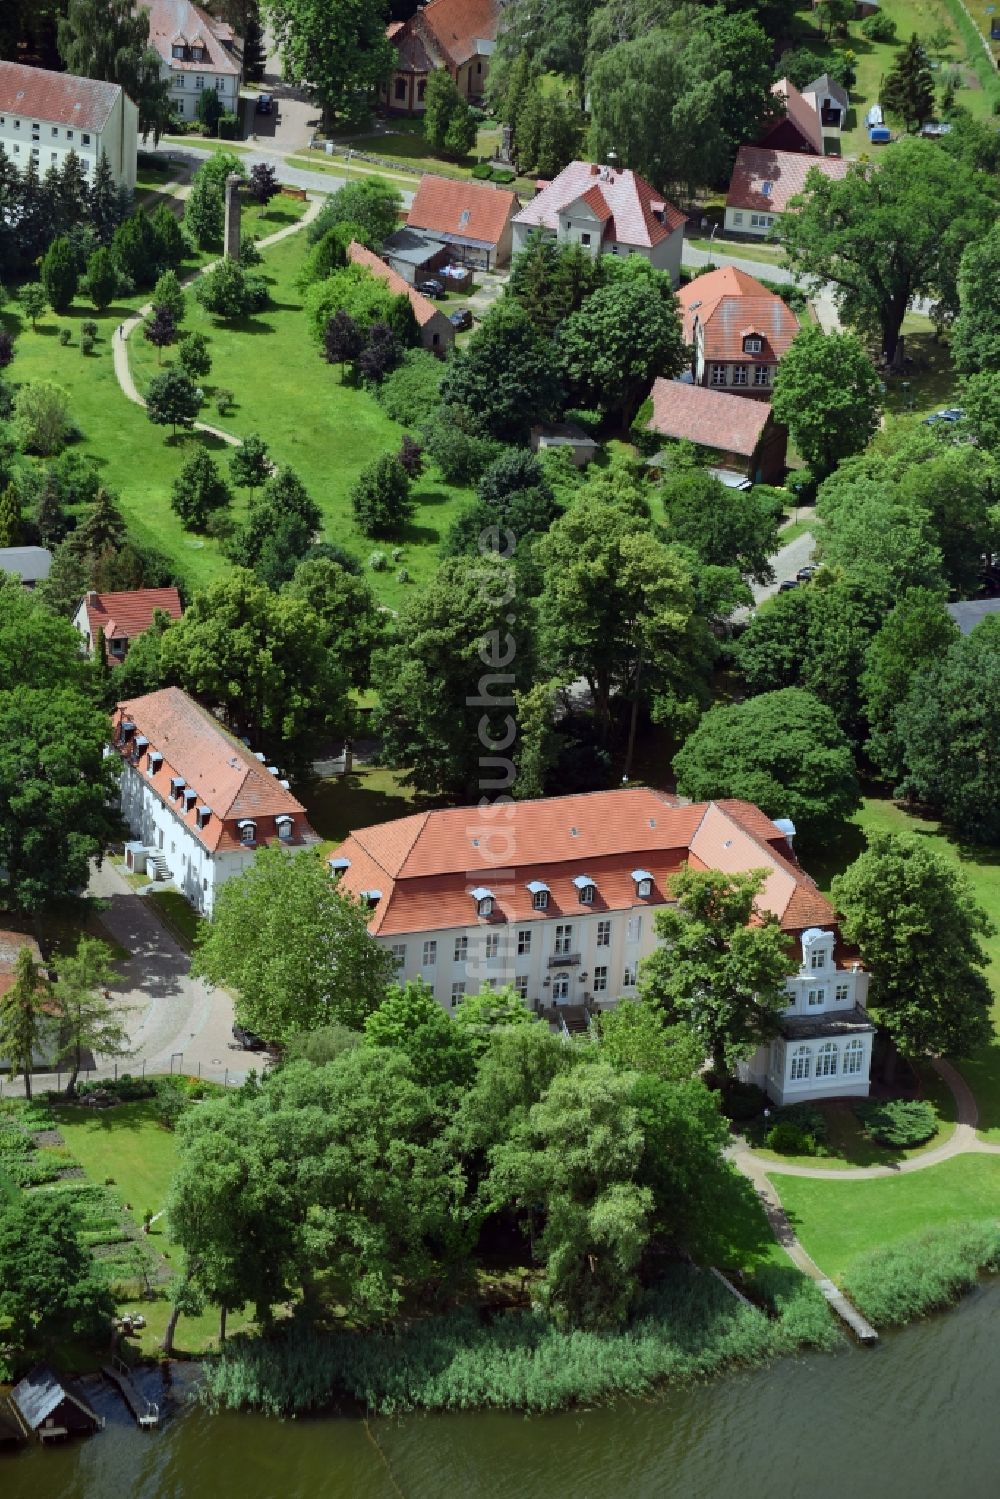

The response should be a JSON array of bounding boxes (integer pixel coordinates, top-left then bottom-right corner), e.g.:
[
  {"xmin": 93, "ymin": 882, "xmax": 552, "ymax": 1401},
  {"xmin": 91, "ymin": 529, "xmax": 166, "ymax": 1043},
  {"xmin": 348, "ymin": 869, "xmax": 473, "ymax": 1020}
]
[{"xmin": 678, "ymin": 265, "xmax": 799, "ymax": 400}]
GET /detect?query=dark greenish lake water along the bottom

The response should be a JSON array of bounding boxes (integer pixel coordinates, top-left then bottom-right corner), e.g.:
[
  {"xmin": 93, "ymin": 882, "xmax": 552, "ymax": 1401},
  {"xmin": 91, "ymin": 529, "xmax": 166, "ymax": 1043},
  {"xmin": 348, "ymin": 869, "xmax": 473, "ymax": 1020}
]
[{"xmin": 7, "ymin": 1282, "xmax": 1000, "ymax": 1499}]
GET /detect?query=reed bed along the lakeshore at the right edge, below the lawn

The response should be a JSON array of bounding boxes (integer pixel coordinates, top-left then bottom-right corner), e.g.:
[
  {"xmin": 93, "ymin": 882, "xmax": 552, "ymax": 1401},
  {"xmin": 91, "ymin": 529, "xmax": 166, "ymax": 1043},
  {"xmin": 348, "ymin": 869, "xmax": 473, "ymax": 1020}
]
[{"xmin": 844, "ymin": 1219, "xmax": 1000, "ymax": 1327}]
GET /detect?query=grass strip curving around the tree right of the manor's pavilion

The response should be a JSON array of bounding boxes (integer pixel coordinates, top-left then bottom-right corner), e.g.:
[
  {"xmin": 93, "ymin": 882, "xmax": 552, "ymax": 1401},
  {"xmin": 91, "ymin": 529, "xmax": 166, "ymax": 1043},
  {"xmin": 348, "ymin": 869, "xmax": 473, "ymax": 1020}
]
[{"xmin": 808, "ymin": 797, "xmax": 1000, "ymax": 1141}]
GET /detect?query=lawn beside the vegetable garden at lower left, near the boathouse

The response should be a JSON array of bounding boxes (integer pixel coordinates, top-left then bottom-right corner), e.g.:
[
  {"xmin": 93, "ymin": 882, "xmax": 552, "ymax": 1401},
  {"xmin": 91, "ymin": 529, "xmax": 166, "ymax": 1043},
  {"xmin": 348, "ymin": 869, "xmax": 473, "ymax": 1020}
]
[{"xmin": 52, "ymin": 1102, "xmax": 256, "ymax": 1357}]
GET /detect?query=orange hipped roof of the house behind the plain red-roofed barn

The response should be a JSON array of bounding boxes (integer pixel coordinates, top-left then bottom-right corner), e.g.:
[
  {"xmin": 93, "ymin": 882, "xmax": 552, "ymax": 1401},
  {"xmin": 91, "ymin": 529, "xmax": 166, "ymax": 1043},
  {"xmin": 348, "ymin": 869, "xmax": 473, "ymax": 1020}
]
[{"xmin": 678, "ymin": 265, "xmax": 799, "ymax": 364}]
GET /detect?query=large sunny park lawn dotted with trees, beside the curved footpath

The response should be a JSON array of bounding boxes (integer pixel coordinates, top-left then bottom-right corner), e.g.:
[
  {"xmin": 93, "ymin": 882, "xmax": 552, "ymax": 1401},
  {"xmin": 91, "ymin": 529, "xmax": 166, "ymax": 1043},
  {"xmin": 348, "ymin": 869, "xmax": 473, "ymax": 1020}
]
[{"xmin": 129, "ymin": 223, "xmax": 468, "ymax": 607}]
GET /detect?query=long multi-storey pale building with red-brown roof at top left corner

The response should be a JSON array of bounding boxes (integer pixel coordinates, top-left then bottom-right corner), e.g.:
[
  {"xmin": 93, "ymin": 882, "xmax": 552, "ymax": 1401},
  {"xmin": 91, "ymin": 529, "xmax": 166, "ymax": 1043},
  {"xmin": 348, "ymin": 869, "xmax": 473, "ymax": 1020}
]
[{"xmin": 0, "ymin": 61, "xmax": 138, "ymax": 187}]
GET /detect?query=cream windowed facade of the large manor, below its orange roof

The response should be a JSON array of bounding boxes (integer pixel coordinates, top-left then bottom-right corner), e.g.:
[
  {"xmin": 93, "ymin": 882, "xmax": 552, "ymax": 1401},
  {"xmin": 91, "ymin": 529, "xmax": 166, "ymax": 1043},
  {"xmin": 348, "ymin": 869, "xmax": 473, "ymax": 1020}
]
[{"xmin": 371, "ymin": 881, "xmax": 657, "ymax": 1010}]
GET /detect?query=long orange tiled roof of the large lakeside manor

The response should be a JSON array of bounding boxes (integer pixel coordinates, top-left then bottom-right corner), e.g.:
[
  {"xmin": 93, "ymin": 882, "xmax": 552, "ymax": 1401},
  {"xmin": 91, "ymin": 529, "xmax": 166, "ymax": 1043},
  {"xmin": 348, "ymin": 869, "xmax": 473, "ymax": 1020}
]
[{"xmin": 337, "ymin": 787, "xmax": 834, "ymax": 937}]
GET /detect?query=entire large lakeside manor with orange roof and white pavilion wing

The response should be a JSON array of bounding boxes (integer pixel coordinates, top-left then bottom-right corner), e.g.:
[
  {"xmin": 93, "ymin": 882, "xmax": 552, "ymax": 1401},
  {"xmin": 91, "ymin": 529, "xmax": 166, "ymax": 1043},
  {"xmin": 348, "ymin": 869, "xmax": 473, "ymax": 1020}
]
[{"xmin": 330, "ymin": 787, "xmax": 874, "ymax": 1103}]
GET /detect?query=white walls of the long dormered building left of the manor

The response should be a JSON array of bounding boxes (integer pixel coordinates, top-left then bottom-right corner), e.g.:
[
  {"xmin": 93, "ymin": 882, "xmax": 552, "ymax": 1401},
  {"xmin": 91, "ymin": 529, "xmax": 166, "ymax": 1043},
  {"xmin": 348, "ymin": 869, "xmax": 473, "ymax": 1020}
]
[{"xmin": 120, "ymin": 761, "xmax": 256, "ymax": 916}]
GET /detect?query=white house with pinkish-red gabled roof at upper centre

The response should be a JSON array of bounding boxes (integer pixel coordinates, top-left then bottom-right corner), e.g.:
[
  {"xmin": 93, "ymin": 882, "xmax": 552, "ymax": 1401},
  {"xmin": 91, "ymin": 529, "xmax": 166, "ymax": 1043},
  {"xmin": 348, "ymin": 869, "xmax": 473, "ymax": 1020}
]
[{"xmin": 514, "ymin": 162, "xmax": 687, "ymax": 286}]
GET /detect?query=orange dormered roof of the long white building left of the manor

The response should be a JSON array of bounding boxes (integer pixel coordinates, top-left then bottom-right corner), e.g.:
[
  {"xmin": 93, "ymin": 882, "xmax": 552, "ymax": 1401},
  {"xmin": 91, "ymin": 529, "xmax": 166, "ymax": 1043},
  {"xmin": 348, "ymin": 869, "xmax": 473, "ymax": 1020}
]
[{"xmin": 112, "ymin": 687, "xmax": 318, "ymax": 853}]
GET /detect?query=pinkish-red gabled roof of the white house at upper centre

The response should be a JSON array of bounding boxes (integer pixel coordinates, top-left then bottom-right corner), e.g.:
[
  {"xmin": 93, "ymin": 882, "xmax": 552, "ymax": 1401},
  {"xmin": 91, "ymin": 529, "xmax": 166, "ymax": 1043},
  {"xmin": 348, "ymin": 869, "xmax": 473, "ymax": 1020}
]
[{"xmin": 517, "ymin": 162, "xmax": 687, "ymax": 249}]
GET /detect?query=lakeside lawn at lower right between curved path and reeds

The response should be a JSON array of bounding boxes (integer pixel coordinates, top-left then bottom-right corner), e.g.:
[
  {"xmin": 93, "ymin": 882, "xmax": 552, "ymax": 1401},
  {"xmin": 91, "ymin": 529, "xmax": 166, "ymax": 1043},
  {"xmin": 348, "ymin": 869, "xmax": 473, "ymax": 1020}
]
[{"xmin": 771, "ymin": 1156, "xmax": 1000, "ymax": 1279}]
